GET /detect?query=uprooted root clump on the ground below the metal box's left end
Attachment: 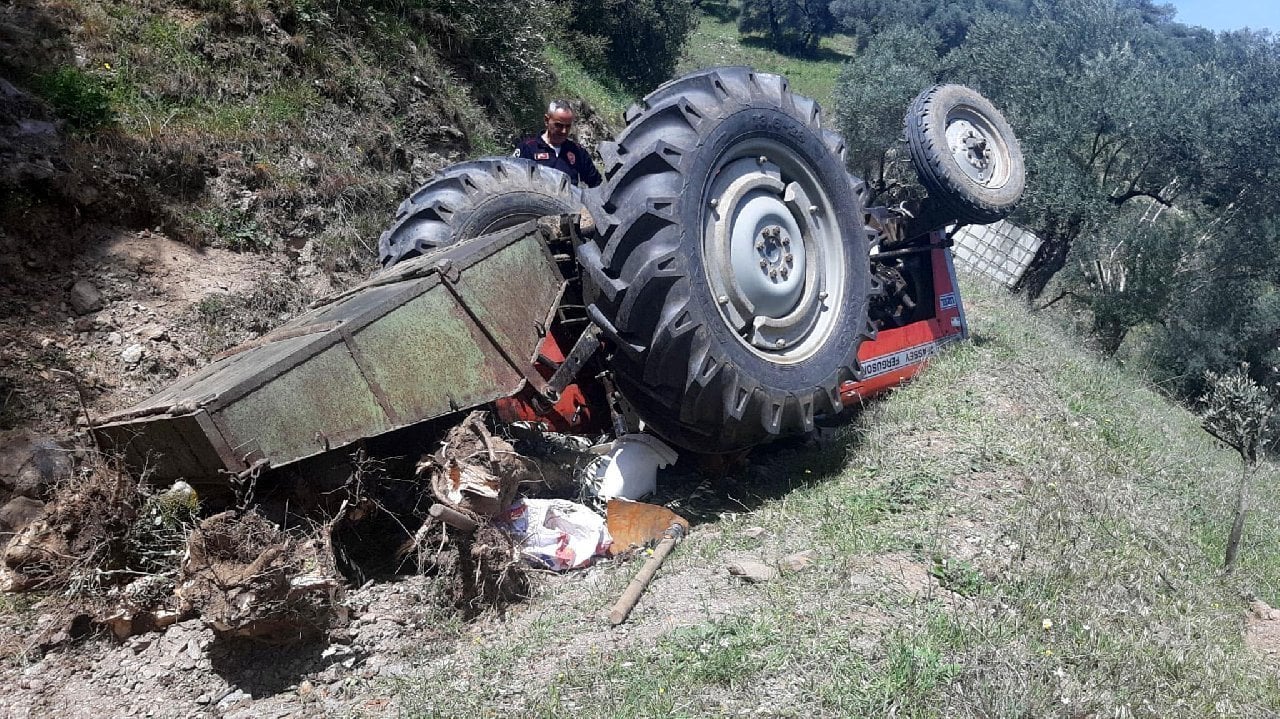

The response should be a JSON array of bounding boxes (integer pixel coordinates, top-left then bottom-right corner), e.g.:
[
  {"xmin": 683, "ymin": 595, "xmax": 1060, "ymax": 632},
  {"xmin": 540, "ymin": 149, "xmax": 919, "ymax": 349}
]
[{"xmin": 177, "ymin": 512, "xmax": 344, "ymax": 644}]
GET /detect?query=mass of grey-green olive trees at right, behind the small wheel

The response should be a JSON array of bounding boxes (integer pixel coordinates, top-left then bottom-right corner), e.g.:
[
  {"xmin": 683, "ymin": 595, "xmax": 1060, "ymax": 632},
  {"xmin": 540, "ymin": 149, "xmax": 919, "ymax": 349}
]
[{"xmin": 832, "ymin": 0, "xmax": 1280, "ymax": 402}]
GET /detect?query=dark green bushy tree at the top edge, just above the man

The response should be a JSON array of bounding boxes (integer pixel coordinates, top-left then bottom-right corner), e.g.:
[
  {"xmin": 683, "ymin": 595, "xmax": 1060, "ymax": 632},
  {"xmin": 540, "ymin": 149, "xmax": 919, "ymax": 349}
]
[{"xmin": 562, "ymin": 0, "xmax": 698, "ymax": 92}]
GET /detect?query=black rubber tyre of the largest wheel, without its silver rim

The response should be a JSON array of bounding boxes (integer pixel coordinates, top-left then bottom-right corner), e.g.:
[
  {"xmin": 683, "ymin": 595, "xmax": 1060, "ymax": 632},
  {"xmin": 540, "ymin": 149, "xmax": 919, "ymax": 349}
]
[{"xmin": 579, "ymin": 68, "xmax": 870, "ymax": 453}]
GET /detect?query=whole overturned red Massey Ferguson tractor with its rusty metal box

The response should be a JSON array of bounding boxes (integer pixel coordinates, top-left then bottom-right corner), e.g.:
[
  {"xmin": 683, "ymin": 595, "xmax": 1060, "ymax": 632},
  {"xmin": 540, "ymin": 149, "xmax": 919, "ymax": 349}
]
[{"xmin": 95, "ymin": 68, "xmax": 1023, "ymax": 485}]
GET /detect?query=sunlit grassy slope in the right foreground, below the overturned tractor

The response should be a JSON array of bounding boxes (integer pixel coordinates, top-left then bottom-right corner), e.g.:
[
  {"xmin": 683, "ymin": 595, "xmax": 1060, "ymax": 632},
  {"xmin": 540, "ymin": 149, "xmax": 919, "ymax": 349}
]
[{"xmin": 397, "ymin": 275, "xmax": 1280, "ymax": 718}]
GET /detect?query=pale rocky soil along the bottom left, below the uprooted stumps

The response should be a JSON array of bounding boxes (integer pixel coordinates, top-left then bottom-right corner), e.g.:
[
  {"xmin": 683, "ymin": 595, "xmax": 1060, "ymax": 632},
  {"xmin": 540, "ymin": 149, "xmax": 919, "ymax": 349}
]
[{"xmin": 0, "ymin": 577, "xmax": 450, "ymax": 719}]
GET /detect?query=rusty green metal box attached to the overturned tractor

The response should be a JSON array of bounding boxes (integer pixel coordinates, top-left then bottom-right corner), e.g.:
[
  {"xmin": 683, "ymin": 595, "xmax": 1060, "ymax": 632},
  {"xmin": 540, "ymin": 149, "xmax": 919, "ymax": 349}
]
[{"xmin": 93, "ymin": 223, "xmax": 566, "ymax": 482}]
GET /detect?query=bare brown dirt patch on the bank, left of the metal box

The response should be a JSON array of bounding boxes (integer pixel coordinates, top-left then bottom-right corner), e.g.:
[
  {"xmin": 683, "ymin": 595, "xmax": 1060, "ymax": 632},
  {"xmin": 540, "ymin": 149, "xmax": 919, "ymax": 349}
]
[{"xmin": 0, "ymin": 229, "xmax": 285, "ymax": 434}]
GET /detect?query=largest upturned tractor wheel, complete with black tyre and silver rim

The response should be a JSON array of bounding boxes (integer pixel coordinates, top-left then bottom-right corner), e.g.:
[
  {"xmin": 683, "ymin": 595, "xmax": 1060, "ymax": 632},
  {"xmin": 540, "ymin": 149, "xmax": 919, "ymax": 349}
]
[{"xmin": 579, "ymin": 68, "xmax": 870, "ymax": 453}]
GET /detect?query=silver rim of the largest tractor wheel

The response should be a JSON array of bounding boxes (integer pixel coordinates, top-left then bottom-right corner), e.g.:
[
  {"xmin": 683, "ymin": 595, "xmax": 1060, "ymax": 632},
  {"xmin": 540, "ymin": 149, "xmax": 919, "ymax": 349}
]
[{"xmin": 701, "ymin": 138, "xmax": 847, "ymax": 363}]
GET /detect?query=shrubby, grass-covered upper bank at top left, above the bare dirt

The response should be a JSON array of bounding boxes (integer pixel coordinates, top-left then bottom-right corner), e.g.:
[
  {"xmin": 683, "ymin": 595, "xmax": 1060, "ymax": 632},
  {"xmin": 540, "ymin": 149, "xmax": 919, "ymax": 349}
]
[{"xmin": 0, "ymin": 0, "xmax": 521, "ymax": 275}]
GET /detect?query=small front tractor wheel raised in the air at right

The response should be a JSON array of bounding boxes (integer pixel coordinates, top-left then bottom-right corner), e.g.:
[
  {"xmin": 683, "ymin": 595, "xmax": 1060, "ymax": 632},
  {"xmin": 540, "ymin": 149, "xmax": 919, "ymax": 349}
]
[{"xmin": 906, "ymin": 84, "xmax": 1025, "ymax": 229}]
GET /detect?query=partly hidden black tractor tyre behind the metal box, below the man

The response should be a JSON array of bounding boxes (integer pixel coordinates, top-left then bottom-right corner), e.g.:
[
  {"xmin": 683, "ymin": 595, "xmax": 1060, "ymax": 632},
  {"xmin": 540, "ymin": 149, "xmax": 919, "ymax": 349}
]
[{"xmin": 378, "ymin": 157, "xmax": 582, "ymax": 267}]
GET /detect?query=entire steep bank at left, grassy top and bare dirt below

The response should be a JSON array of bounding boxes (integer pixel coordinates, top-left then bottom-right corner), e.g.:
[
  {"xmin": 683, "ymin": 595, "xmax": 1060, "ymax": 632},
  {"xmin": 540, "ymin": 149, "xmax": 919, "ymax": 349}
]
[{"xmin": 0, "ymin": 0, "xmax": 517, "ymax": 431}]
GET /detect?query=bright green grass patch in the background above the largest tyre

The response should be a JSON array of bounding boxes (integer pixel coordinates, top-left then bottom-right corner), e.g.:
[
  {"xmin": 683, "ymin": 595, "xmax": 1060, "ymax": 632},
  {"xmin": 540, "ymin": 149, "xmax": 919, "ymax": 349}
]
[{"xmin": 676, "ymin": 8, "xmax": 854, "ymax": 109}]
